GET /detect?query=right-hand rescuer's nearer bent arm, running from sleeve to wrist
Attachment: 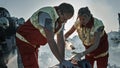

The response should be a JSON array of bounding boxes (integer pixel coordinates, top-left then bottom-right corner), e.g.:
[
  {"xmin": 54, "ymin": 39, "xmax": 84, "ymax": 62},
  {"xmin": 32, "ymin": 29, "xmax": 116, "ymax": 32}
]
[{"xmin": 83, "ymin": 26, "xmax": 104, "ymax": 55}]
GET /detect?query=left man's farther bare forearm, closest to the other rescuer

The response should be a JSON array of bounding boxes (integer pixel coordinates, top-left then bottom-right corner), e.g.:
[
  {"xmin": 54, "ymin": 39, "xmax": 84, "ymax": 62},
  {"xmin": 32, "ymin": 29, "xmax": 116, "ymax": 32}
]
[{"xmin": 57, "ymin": 26, "xmax": 65, "ymax": 58}]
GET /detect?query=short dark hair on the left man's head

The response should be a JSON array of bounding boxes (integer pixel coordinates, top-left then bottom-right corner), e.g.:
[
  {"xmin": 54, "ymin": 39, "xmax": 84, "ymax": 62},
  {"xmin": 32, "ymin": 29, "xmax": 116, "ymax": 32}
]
[{"xmin": 58, "ymin": 3, "xmax": 74, "ymax": 15}]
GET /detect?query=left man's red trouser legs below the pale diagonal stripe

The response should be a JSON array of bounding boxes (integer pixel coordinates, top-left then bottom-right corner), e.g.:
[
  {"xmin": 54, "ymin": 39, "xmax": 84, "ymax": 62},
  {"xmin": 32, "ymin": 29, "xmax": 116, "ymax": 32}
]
[{"xmin": 16, "ymin": 38, "xmax": 39, "ymax": 68}]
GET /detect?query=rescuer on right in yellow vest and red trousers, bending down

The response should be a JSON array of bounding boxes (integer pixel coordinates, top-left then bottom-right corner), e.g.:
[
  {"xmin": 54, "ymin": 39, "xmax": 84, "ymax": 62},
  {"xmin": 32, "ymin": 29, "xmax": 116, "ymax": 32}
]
[{"xmin": 65, "ymin": 7, "xmax": 108, "ymax": 68}]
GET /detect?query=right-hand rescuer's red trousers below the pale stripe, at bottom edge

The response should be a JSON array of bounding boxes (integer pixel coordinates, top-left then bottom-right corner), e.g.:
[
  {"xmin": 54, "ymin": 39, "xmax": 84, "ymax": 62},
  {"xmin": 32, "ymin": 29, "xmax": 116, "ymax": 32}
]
[{"xmin": 85, "ymin": 55, "xmax": 108, "ymax": 68}]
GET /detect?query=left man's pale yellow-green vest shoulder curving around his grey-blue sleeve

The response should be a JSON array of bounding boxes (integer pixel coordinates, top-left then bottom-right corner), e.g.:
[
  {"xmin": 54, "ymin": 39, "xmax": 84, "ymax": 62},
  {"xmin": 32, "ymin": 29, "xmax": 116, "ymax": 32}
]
[{"xmin": 30, "ymin": 7, "xmax": 59, "ymax": 37}]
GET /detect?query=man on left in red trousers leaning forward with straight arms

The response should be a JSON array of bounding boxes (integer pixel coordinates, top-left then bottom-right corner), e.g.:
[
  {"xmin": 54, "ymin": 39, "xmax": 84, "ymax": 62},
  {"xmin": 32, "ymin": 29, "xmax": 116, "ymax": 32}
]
[{"xmin": 16, "ymin": 3, "xmax": 74, "ymax": 68}]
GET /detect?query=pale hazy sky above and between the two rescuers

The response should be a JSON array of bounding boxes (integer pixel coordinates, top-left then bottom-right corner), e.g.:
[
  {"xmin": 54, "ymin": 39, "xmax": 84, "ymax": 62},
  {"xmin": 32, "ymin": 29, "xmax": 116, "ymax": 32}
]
[{"xmin": 0, "ymin": 0, "xmax": 120, "ymax": 36}]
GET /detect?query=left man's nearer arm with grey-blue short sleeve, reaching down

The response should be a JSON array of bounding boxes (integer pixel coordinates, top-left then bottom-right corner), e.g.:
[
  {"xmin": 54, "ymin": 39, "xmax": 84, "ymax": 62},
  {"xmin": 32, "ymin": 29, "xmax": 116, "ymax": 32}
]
[{"xmin": 39, "ymin": 13, "xmax": 64, "ymax": 62}]
